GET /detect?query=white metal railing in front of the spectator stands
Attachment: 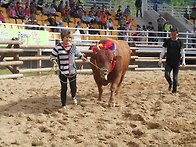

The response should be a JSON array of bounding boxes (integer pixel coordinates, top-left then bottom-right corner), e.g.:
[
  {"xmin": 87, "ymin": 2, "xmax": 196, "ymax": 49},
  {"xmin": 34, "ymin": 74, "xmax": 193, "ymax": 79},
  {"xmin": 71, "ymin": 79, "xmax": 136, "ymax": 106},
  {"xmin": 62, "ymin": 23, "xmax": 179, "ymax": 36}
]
[{"xmin": 0, "ymin": 23, "xmax": 196, "ymax": 48}]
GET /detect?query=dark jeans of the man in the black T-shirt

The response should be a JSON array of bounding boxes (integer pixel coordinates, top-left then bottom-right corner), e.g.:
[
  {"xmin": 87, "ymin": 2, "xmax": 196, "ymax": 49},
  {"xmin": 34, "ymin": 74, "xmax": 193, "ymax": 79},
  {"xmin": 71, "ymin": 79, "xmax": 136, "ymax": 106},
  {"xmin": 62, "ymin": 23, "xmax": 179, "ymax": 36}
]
[{"xmin": 165, "ymin": 64, "xmax": 180, "ymax": 92}]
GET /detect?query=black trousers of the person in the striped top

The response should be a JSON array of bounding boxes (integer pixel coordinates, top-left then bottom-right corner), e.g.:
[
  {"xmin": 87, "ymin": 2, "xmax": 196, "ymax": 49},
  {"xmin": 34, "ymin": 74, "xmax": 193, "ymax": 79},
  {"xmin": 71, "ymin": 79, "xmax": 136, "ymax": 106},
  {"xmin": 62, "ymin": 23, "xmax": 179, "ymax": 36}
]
[{"xmin": 59, "ymin": 74, "xmax": 77, "ymax": 106}]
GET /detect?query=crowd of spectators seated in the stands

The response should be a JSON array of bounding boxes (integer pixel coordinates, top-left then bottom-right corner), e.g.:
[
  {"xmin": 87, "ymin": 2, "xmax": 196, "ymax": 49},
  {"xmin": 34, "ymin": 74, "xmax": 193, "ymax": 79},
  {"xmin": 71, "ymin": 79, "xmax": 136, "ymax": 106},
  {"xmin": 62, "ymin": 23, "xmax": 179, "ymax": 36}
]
[{"xmin": 0, "ymin": 0, "xmax": 196, "ymax": 44}]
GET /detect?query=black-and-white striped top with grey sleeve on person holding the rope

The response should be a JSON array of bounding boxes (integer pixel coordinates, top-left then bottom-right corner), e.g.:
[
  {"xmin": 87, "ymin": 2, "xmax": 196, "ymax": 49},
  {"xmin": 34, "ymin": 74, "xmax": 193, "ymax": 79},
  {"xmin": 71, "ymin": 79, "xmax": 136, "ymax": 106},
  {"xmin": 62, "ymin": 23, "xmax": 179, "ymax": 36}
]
[{"xmin": 50, "ymin": 44, "xmax": 83, "ymax": 75}]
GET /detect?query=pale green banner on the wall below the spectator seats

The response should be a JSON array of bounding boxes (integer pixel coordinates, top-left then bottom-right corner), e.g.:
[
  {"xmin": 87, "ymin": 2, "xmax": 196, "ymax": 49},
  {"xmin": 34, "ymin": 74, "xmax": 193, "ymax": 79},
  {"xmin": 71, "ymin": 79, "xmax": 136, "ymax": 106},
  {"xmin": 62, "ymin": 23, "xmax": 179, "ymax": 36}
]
[{"xmin": 0, "ymin": 29, "xmax": 49, "ymax": 46}]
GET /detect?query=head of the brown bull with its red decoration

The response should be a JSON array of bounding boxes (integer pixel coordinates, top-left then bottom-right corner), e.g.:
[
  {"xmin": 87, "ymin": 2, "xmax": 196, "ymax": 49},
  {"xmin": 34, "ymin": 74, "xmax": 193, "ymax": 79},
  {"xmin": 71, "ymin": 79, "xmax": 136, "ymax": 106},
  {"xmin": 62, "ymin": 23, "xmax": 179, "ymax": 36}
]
[{"xmin": 90, "ymin": 44, "xmax": 116, "ymax": 80}]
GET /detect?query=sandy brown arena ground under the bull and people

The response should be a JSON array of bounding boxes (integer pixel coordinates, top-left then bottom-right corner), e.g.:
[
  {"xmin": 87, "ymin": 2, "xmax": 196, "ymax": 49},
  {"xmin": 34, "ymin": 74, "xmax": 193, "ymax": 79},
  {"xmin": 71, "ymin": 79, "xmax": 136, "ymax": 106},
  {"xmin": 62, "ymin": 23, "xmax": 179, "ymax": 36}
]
[{"xmin": 0, "ymin": 71, "xmax": 196, "ymax": 147}]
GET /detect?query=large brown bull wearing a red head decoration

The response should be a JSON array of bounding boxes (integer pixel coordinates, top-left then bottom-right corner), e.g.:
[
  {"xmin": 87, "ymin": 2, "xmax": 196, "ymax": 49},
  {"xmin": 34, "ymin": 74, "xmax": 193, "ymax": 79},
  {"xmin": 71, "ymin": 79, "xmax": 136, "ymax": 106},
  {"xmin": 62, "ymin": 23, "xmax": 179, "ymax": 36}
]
[{"xmin": 90, "ymin": 39, "xmax": 131, "ymax": 106}]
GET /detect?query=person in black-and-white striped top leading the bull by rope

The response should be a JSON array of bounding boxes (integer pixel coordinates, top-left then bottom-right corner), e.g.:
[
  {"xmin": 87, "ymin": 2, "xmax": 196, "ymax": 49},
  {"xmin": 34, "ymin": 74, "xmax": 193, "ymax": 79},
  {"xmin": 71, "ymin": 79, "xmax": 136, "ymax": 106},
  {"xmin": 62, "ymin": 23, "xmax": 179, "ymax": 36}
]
[{"xmin": 50, "ymin": 29, "xmax": 86, "ymax": 108}]
